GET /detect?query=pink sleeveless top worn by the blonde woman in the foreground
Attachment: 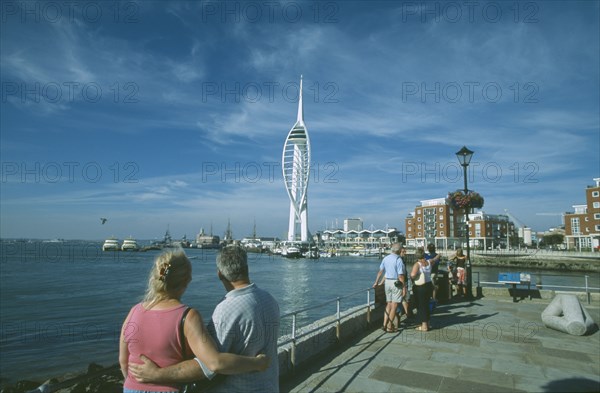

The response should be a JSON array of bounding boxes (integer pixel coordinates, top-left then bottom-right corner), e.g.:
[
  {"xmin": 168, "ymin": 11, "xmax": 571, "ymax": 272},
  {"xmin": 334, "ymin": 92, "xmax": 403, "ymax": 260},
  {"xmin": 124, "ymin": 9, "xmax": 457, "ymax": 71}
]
[{"xmin": 123, "ymin": 303, "xmax": 187, "ymax": 391}]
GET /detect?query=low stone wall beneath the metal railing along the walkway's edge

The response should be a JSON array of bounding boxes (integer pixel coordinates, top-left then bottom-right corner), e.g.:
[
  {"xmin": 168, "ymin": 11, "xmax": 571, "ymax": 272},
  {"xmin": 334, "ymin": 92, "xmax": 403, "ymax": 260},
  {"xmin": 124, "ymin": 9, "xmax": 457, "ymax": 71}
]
[{"xmin": 278, "ymin": 305, "xmax": 383, "ymax": 378}]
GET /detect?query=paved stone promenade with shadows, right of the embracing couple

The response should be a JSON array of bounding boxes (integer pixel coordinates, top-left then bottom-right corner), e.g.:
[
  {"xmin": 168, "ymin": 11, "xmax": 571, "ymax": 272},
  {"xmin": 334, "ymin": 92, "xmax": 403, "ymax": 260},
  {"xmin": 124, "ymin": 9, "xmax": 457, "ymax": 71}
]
[{"xmin": 281, "ymin": 298, "xmax": 600, "ymax": 393}]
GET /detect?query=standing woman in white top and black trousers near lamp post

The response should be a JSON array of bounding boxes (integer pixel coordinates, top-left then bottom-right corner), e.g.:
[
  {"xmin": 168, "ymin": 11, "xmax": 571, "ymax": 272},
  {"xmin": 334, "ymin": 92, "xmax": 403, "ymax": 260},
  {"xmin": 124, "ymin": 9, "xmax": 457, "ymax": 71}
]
[{"xmin": 410, "ymin": 247, "xmax": 433, "ymax": 332}]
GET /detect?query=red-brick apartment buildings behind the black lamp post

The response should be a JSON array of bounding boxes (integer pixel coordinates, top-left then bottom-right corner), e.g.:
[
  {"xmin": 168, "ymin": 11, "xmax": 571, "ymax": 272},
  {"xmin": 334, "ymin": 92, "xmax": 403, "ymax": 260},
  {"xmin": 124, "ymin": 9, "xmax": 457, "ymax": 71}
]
[{"xmin": 405, "ymin": 198, "xmax": 517, "ymax": 250}]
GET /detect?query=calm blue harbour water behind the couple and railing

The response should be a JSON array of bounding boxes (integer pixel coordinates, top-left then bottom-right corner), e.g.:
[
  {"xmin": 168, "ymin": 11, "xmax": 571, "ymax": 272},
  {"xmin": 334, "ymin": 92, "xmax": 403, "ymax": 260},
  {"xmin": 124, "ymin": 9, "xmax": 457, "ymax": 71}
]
[{"xmin": 0, "ymin": 242, "xmax": 600, "ymax": 382}]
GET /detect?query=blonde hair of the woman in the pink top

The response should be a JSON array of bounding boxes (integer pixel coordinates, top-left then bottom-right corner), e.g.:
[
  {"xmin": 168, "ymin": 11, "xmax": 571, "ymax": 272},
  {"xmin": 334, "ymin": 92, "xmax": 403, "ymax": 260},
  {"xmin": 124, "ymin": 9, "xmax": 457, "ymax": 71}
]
[{"xmin": 144, "ymin": 250, "xmax": 192, "ymax": 309}]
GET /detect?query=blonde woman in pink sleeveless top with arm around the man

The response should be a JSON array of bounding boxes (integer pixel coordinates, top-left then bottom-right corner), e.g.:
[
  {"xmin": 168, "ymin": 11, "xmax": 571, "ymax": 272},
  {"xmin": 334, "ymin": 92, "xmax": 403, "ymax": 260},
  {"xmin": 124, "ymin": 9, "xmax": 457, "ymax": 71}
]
[{"xmin": 119, "ymin": 251, "xmax": 269, "ymax": 393}]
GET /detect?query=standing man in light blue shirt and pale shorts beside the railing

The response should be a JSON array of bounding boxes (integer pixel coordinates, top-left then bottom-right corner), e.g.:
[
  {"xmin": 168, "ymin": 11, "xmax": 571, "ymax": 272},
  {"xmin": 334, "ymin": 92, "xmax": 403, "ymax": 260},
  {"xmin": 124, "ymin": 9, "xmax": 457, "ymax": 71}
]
[{"xmin": 373, "ymin": 243, "xmax": 406, "ymax": 333}]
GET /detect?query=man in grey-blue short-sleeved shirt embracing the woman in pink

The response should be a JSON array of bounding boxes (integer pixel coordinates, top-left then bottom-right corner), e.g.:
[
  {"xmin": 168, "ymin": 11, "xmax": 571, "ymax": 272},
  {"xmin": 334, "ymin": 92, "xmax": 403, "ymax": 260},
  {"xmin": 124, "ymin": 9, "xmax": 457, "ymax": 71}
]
[{"xmin": 130, "ymin": 246, "xmax": 280, "ymax": 393}]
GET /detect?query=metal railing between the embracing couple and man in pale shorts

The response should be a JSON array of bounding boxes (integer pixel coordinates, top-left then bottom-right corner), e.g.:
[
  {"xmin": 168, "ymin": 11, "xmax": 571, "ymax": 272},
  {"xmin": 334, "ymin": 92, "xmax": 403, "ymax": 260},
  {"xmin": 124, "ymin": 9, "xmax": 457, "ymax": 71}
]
[{"xmin": 277, "ymin": 288, "xmax": 375, "ymax": 368}]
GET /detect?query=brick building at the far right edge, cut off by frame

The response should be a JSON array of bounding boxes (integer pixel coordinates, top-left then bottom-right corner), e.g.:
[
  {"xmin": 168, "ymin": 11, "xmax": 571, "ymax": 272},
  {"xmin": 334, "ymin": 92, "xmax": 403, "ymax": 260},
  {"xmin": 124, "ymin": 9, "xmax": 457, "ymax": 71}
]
[{"xmin": 564, "ymin": 178, "xmax": 600, "ymax": 250}]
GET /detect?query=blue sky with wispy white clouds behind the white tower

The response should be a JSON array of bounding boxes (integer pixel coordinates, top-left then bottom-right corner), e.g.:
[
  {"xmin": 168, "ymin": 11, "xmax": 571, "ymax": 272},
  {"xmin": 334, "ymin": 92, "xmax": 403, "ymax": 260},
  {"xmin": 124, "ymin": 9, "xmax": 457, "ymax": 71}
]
[{"xmin": 0, "ymin": 1, "xmax": 600, "ymax": 240}]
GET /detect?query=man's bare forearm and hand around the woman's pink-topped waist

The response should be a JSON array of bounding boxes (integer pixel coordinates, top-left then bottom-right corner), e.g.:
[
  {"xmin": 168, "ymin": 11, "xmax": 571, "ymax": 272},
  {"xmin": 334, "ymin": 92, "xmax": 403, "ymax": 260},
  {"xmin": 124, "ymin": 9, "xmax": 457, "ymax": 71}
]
[{"xmin": 129, "ymin": 355, "xmax": 204, "ymax": 384}]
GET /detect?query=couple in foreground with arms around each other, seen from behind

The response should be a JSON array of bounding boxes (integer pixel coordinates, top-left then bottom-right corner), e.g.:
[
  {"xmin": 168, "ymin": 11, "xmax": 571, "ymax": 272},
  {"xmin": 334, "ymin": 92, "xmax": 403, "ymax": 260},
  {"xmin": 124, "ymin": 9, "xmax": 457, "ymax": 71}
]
[{"xmin": 119, "ymin": 246, "xmax": 280, "ymax": 393}]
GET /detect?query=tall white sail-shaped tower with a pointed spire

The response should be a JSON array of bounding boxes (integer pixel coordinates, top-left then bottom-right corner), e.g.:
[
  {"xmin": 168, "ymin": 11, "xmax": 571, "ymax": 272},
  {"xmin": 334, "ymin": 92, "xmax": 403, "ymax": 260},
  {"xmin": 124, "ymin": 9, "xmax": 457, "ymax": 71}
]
[{"xmin": 281, "ymin": 75, "xmax": 310, "ymax": 242}]
